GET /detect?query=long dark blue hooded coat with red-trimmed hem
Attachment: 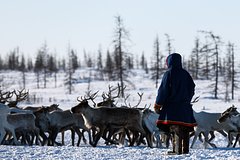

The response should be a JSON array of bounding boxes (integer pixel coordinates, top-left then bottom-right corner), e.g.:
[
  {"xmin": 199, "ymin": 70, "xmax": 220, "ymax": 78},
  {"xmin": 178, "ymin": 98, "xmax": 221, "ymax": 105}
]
[{"xmin": 156, "ymin": 53, "xmax": 197, "ymax": 129}]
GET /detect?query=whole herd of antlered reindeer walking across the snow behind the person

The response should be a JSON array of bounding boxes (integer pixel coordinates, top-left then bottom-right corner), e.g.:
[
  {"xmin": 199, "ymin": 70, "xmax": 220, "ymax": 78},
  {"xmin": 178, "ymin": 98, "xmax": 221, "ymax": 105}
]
[{"xmin": 0, "ymin": 85, "xmax": 240, "ymax": 148}]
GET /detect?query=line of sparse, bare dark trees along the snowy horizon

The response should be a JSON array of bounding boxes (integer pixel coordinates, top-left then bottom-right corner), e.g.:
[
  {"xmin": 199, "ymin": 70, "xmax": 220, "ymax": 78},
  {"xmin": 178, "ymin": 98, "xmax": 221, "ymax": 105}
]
[{"xmin": 0, "ymin": 16, "xmax": 239, "ymax": 101}]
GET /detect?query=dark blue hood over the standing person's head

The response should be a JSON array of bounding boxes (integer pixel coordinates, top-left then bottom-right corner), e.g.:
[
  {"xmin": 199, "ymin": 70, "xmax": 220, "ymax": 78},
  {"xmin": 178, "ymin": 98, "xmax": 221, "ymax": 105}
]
[{"xmin": 166, "ymin": 53, "xmax": 182, "ymax": 68}]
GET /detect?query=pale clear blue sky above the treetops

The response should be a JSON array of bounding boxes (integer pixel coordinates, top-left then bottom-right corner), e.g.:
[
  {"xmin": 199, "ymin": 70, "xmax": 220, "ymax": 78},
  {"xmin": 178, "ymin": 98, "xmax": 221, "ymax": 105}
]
[{"xmin": 0, "ymin": 0, "xmax": 240, "ymax": 59}]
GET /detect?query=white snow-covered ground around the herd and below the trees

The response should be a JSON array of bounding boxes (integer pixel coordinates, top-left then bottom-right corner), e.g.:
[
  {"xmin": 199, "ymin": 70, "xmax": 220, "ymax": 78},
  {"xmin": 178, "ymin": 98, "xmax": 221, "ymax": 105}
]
[{"xmin": 0, "ymin": 70, "xmax": 240, "ymax": 160}]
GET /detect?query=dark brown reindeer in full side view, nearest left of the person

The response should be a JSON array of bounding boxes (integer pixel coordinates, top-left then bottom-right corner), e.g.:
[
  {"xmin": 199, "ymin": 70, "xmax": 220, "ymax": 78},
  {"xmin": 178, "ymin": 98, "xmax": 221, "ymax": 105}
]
[{"xmin": 71, "ymin": 94, "xmax": 152, "ymax": 147}]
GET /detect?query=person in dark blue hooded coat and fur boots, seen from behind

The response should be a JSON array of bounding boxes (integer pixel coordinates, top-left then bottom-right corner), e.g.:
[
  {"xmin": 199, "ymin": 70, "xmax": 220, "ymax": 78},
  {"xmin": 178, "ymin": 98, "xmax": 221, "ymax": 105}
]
[{"xmin": 154, "ymin": 53, "xmax": 197, "ymax": 154}]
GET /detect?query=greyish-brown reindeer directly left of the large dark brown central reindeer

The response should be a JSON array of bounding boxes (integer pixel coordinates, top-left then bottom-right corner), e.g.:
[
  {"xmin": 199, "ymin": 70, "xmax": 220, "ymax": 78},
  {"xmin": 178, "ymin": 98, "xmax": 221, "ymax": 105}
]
[{"xmin": 34, "ymin": 107, "xmax": 90, "ymax": 146}]
